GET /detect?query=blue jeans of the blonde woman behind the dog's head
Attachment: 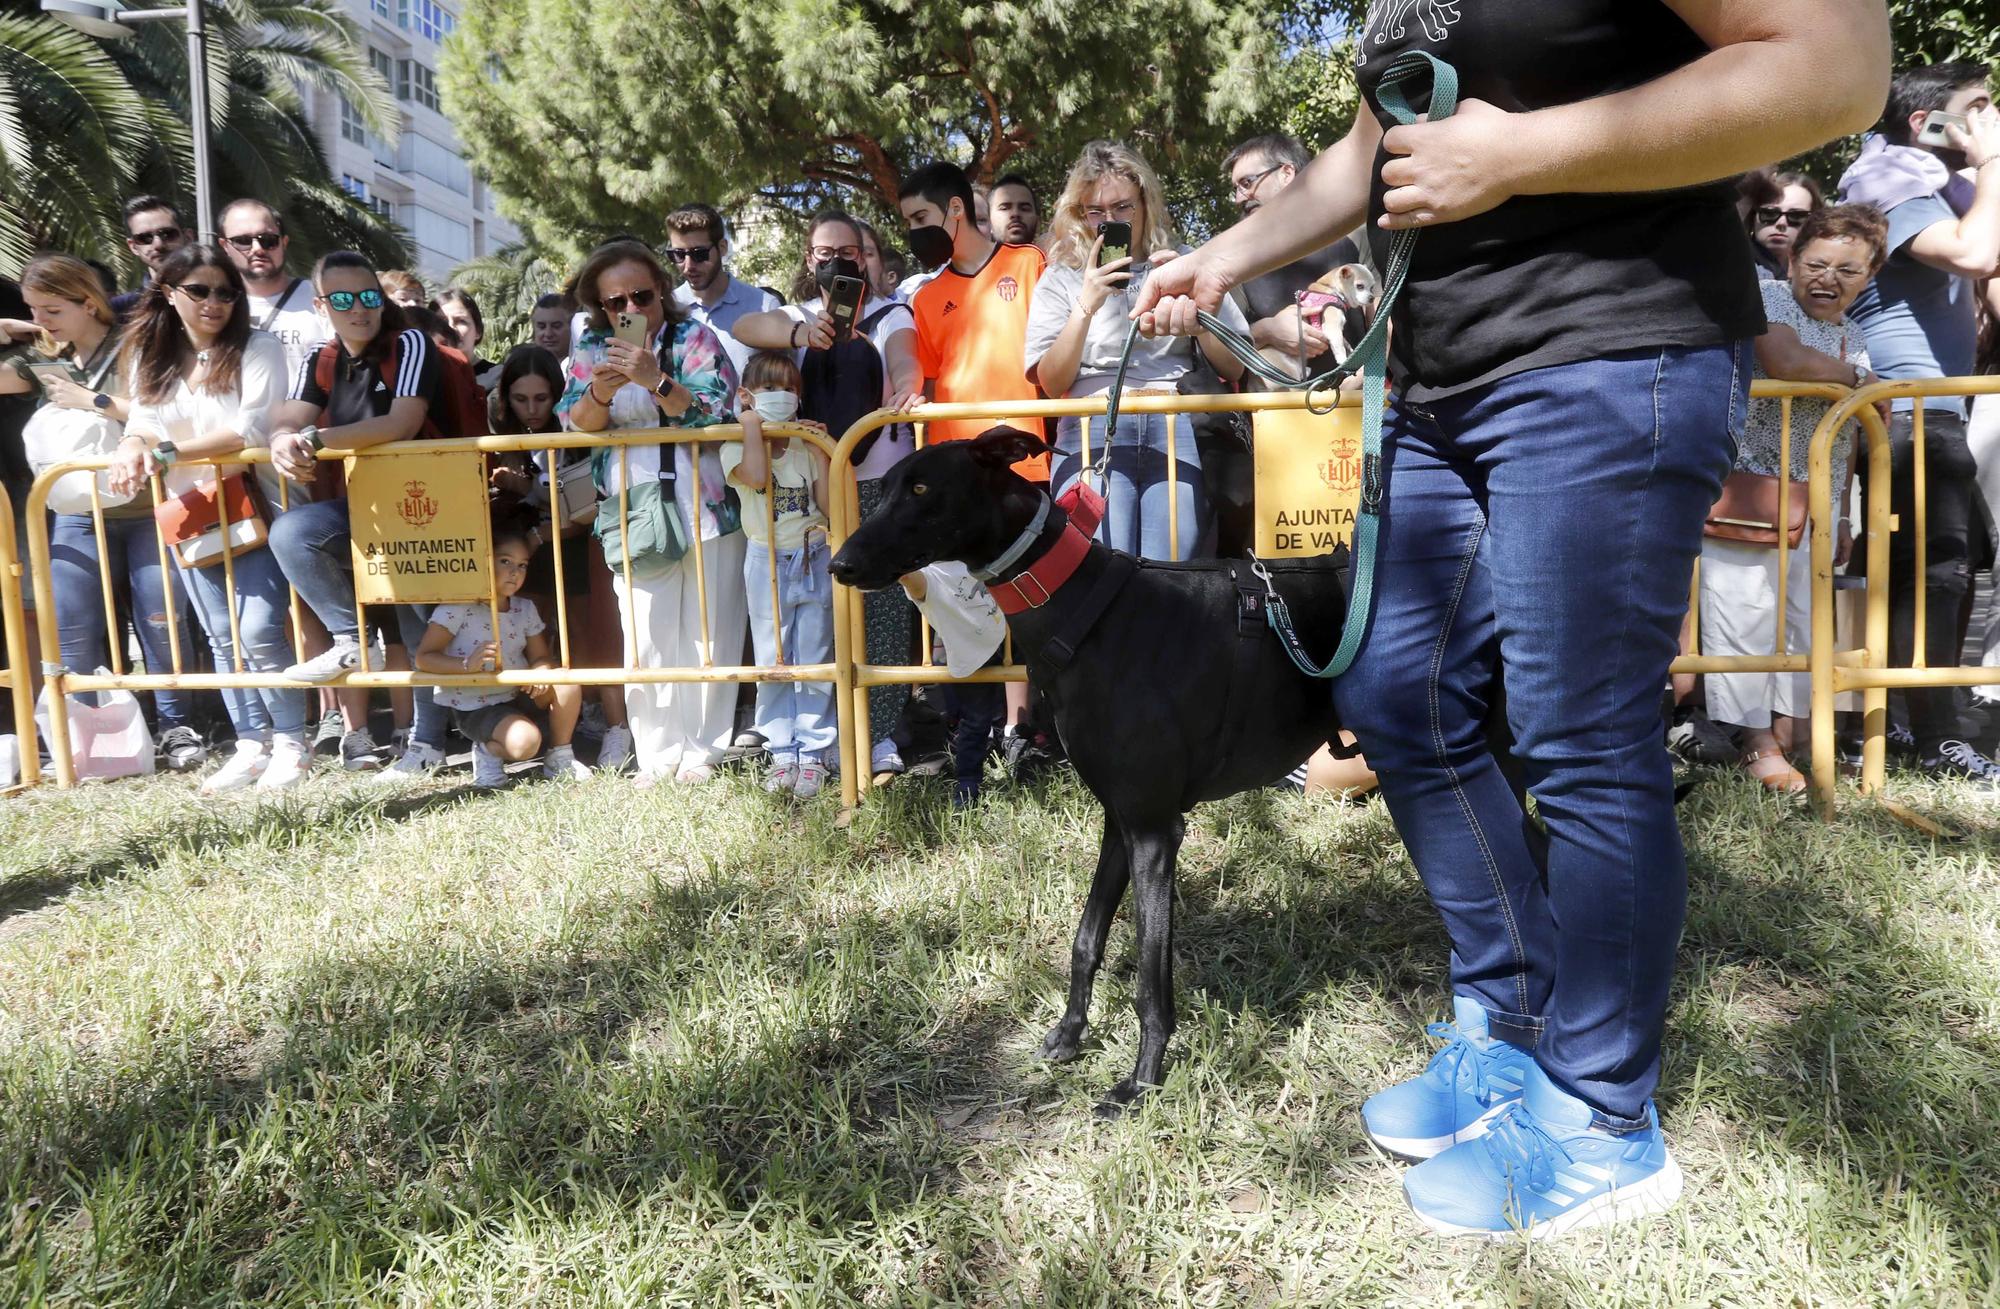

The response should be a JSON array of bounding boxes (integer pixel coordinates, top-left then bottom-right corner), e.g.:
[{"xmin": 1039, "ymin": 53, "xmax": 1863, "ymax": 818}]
[{"xmin": 1048, "ymin": 414, "xmax": 1208, "ymax": 560}]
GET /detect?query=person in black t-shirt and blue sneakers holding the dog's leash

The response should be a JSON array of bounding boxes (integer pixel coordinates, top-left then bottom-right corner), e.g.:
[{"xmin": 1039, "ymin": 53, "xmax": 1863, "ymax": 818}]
[{"xmin": 1134, "ymin": 0, "xmax": 1888, "ymax": 1235}]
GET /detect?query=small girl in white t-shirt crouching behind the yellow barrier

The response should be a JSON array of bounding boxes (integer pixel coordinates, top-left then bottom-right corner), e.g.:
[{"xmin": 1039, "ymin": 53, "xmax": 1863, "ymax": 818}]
[{"xmin": 416, "ymin": 526, "xmax": 590, "ymax": 789}]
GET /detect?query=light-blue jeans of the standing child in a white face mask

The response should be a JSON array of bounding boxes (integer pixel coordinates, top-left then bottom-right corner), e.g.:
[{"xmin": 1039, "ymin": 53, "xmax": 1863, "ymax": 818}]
[{"xmin": 744, "ymin": 536, "xmax": 838, "ymax": 761}]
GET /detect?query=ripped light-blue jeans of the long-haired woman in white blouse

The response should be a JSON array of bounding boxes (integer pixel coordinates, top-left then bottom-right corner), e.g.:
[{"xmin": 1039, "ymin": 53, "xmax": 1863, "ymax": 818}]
[{"xmin": 174, "ymin": 548, "xmax": 306, "ymax": 743}]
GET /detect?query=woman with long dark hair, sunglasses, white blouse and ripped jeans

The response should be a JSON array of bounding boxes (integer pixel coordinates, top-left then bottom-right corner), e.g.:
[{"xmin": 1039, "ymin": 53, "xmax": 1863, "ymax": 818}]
[{"xmin": 110, "ymin": 246, "xmax": 312, "ymax": 795}]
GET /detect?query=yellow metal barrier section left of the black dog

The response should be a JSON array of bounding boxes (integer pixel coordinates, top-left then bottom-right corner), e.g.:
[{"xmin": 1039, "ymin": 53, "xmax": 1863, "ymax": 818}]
[{"xmin": 31, "ymin": 422, "xmax": 848, "ymax": 787}]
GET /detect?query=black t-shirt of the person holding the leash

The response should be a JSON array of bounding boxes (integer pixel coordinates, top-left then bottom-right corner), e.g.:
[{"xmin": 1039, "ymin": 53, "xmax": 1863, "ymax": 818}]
[{"xmin": 1354, "ymin": 0, "xmax": 1764, "ymax": 402}]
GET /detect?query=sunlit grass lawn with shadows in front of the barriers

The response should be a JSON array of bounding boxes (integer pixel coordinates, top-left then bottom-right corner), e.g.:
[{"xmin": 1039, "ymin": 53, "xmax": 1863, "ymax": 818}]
[{"xmin": 0, "ymin": 775, "xmax": 2000, "ymax": 1307}]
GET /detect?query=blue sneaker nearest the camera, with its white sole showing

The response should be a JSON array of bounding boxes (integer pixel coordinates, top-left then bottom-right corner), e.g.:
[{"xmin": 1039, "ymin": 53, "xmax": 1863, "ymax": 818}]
[{"xmin": 1402, "ymin": 1065, "xmax": 1680, "ymax": 1241}]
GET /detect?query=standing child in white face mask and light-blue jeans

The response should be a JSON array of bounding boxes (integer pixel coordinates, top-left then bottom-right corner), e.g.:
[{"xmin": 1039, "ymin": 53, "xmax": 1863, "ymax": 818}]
[{"xmin": 722, "ymin": 352, "xmax": 838, "ymax": 799}]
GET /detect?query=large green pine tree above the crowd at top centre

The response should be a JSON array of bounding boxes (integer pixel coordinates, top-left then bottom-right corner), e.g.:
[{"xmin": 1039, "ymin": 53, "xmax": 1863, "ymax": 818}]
[{"xmin": 442, "ymin": 0, "xmax": 1284, "ymax": 254}]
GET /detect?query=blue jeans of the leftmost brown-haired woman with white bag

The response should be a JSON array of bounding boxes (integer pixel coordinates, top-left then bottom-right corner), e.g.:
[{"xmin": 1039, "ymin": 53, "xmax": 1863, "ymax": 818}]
[{"xmin": 48, "ymin": 514, "xmax": 194, "ymax": 731}]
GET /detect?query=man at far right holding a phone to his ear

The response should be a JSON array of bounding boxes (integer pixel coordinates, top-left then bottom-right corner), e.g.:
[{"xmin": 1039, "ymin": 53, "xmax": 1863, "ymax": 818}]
[{"xmin": 1840, "ymin": 62, "xmax": 2000, "ymax": 789}]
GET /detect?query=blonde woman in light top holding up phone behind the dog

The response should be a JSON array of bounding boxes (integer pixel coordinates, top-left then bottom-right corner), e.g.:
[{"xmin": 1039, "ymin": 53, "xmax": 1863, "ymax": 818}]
[{"xmin": 1026, "ymin": 140, "xmax": 1250, "ymax": 558}]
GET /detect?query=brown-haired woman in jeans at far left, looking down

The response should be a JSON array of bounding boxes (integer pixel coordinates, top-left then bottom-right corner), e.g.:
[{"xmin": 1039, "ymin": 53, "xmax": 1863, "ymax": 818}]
[{"xmin": 0, "ymin": 254, "xmax": 208, "ymax": 773}]
